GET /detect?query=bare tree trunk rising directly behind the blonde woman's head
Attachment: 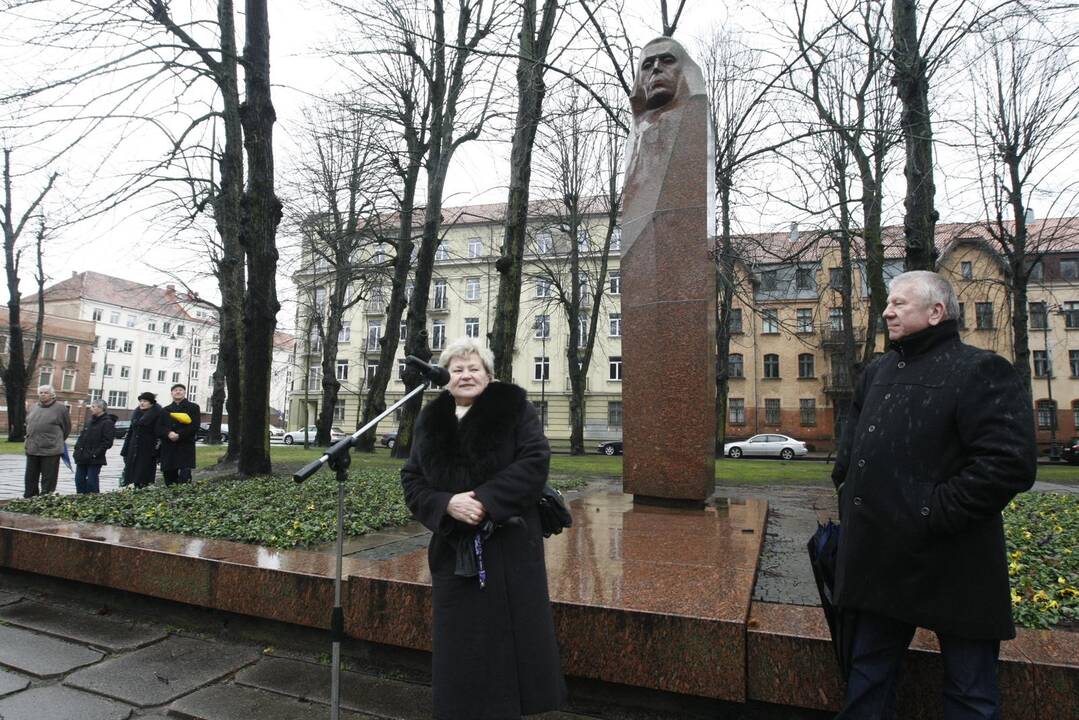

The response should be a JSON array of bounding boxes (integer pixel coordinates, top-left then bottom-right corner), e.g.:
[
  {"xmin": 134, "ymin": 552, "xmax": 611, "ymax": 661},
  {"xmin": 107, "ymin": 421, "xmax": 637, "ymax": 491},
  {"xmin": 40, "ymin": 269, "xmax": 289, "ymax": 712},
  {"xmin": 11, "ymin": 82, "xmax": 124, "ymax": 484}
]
[{"xmin": 491, "ymin": 0, "xmax": 561, "ymax": 382}]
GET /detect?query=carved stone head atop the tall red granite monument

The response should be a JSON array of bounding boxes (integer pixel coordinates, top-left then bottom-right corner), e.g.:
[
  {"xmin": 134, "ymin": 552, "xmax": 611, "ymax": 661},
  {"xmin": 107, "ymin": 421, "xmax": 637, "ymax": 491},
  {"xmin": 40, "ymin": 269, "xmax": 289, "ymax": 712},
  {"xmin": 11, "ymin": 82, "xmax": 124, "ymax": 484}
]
[{"xmin": 629, "ymin": 38, "xmax": 705, "ymax": 118}]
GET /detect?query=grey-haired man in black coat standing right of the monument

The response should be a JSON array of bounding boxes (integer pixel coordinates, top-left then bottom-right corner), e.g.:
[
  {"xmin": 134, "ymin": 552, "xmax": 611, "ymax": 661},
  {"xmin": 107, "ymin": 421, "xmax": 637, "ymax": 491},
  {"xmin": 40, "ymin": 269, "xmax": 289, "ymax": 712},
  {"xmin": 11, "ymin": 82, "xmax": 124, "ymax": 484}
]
[{"xmin": 832, "ymin": 271, "xmax": 1037, "ymax": 720}]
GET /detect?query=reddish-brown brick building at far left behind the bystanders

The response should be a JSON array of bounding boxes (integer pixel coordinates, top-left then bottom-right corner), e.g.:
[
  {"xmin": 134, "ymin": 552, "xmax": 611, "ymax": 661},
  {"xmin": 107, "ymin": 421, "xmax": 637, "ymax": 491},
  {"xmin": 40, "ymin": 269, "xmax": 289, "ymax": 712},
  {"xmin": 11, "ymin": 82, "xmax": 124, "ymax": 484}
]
[{"xmin": 0, "ymin": 308, "xmax": 94, "ymax": 430}]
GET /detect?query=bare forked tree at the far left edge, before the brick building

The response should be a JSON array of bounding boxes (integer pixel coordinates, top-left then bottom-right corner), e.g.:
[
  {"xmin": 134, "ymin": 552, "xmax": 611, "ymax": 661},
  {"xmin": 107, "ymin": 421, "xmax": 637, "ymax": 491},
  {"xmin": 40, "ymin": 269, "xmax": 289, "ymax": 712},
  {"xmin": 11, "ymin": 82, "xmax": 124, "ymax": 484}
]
[{"xmin": 0, "ymin": 148, "xmax": 56, "ymax": 443}]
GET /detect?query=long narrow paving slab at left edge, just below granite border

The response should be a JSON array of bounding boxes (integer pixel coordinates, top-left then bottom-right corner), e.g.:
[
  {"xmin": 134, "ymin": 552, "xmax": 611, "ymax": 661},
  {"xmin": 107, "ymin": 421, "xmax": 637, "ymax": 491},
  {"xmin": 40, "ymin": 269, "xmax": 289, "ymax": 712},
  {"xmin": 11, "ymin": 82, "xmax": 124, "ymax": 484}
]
[{"xmin": 0, "ymin": 602, "xmax": 167, "ymax": 652}]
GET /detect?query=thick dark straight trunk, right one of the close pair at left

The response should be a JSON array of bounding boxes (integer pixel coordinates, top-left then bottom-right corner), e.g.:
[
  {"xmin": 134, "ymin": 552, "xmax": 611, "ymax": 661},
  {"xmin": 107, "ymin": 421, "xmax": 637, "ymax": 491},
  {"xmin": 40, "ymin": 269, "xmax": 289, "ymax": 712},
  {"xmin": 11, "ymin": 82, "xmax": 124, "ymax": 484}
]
[{"xmin": 238, "ymin": 0, "xmax": 282, "ymax": 475}]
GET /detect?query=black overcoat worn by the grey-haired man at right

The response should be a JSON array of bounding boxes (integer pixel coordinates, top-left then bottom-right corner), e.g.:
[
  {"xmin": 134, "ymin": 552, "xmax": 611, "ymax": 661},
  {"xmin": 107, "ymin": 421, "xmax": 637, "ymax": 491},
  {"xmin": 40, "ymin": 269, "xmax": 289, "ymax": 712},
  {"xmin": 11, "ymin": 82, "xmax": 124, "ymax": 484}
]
[{"xmin": 832, "ymin": 321, "xmax": 1037, "ymax": 640}]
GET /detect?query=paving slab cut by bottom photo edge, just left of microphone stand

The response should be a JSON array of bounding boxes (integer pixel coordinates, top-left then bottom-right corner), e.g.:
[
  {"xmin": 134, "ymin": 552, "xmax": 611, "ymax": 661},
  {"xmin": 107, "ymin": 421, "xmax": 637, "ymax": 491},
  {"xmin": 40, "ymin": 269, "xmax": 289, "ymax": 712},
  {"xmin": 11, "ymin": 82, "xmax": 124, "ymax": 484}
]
[{"xmin": 168, "ymin": 684, "xmax": 371, "ymax": 720}]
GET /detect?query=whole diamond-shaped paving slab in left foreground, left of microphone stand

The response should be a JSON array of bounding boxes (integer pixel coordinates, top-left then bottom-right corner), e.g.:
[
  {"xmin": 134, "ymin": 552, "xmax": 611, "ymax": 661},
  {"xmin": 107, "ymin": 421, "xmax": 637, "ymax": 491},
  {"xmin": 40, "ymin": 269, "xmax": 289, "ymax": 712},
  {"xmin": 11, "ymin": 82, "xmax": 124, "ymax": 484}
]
[{"xmin": 64, "ymin": 637, "xmax": 258, "ymax": 707}]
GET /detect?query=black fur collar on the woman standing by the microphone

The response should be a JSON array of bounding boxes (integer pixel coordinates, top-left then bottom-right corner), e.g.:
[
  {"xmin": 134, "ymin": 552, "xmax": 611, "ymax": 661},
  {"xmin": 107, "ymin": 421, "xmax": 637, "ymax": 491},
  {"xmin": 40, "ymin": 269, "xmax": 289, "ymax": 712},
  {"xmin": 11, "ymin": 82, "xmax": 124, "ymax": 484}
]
[{"xmin": 416, "ymin": 382, "xmax": 528, "ymax": 492}]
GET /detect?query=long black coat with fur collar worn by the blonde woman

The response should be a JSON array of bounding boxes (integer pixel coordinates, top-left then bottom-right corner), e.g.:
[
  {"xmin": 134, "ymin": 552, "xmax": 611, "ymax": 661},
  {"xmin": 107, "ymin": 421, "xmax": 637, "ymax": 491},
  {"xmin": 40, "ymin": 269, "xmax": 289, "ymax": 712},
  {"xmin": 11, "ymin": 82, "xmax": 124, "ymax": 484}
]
[{"xmin": 401, "ymin": 382, "xmax": 565, "ymax": 720}]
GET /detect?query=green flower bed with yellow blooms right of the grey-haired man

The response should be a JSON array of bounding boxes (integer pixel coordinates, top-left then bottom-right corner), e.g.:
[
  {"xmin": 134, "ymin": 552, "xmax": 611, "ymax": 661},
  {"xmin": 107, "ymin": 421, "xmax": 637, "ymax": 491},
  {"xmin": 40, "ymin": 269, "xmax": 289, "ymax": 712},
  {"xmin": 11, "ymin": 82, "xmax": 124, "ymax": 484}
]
[{"xmin": 1005, "ymin": 492, "xmax": 1079, "ymax": 627}]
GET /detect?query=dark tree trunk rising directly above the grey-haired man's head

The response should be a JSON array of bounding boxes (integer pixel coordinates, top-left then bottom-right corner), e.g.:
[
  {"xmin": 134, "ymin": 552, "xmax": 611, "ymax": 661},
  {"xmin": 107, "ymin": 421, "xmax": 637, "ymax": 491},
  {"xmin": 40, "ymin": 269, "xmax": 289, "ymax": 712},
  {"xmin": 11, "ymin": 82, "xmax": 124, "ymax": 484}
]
[{"xmin": 891, "ymin": 0, "xmax": 938, "ymax": 270}]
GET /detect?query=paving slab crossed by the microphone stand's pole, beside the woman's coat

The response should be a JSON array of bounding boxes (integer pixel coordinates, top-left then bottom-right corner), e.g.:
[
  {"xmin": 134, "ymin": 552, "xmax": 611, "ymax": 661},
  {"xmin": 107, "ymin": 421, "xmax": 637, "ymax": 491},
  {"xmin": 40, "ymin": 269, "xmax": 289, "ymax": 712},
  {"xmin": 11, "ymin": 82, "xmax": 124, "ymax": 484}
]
[{"xmin": 236, "ymin": 657, "xmax": 434, "ymax": 720}]
